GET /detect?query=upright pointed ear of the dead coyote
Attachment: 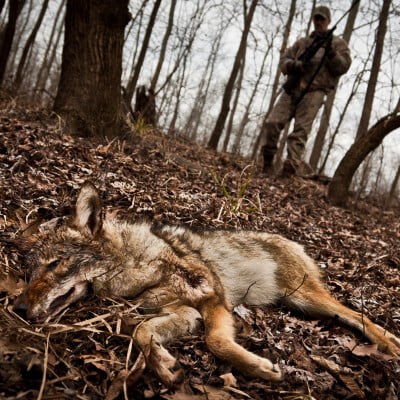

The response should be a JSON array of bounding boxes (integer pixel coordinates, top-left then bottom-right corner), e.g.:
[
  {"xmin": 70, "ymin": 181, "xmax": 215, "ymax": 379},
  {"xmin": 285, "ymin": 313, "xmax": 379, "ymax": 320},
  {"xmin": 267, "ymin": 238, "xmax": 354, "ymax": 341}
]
[{"xmin": 73, "ymin": 182, "xmax": 103, "ymax": 236}]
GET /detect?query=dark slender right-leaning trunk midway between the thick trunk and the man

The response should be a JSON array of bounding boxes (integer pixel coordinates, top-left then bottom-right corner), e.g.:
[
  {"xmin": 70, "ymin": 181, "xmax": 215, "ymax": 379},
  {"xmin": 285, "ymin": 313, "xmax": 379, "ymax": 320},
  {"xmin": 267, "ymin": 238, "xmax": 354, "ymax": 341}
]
[{"xmin": 208, "ymin": 0, "xmax": 258, "ymax": 150}]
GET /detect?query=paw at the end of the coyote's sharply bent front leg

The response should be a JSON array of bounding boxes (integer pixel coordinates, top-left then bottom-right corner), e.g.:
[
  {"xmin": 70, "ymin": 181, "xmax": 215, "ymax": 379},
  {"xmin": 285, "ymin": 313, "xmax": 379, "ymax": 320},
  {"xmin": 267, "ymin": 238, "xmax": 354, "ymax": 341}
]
[{"xmin": 149, "ymin": 345, "xmax": 183, "ymax": 387}]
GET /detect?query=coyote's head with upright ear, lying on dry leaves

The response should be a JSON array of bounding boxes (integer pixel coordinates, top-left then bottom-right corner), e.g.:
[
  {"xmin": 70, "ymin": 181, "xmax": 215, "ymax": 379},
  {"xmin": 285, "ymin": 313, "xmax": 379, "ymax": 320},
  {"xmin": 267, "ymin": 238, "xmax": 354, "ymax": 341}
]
[{"xmin": 14, "ymin": 183, "xmax": 113, "ymax": 321}]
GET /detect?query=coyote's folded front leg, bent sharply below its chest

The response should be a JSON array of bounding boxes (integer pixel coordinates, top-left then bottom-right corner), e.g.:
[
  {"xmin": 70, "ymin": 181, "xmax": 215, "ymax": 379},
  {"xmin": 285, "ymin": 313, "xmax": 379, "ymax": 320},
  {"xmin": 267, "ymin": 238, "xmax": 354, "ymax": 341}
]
[{"xmin": 134, "ymin": 305, "xmax": 201, "ymax": 386}]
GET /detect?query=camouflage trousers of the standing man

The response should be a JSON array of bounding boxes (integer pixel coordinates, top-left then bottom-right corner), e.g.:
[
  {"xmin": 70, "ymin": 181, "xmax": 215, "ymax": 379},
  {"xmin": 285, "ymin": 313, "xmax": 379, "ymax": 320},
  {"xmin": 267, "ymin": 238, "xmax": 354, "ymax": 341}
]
[{"xmin": 262, "ymin": 90, "xmax": 325, "ymax": 170}]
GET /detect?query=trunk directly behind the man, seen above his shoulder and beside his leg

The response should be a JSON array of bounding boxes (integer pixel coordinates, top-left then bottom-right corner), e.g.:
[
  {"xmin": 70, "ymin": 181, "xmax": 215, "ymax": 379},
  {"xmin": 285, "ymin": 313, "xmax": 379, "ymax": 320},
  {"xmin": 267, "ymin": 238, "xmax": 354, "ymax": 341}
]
[{"xmin": 310, "ymin": 2, "xmax": 360, "ymax": 170}]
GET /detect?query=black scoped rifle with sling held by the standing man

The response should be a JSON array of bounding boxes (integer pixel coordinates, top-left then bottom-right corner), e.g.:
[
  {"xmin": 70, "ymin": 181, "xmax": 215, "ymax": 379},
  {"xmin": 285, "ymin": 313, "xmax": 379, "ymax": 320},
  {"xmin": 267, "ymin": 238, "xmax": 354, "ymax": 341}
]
[{"xmin": 283, "ymin": 0, "xmax": 360, "ymax": 97}]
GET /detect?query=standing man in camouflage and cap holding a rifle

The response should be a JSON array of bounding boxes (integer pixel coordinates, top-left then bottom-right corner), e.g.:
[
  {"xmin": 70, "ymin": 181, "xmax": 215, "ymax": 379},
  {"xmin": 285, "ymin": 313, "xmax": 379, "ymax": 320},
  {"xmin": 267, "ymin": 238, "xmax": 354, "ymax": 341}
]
[{"xmin": 262, "ymin": 6, "xmax": 351, "ymax": 177}]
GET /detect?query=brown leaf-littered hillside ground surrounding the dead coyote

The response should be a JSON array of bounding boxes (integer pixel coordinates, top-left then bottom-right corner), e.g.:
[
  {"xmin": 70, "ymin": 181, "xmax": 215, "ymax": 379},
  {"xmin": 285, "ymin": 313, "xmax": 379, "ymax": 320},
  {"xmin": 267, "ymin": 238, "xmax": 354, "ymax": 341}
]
[{"xmin": 0, "ymin": 104, "xmax": 400, "ymax": 400}]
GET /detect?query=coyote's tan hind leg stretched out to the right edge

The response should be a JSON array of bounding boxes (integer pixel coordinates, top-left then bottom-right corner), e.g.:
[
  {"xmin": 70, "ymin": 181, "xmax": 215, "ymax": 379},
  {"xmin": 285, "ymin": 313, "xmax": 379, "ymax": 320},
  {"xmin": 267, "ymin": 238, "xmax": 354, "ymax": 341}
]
[{"xmin": 284, "ymin": 279, "xmax": 400, "ymax": 358}]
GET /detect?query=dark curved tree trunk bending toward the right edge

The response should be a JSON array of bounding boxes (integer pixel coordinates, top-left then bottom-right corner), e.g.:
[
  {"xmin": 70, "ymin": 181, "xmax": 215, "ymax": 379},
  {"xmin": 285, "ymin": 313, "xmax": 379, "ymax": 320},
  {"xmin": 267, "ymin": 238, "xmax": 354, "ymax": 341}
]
[{"xmin": 328, "ymin": 112, "xmax": 400, "ymax": 207}]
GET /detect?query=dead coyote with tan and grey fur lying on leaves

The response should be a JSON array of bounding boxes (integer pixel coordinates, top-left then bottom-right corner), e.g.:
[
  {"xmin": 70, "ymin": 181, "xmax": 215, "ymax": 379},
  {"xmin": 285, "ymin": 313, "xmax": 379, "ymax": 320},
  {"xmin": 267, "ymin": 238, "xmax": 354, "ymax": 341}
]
[{"xmin": 15, "ymin": 183, "xmax": 400, "ymax": 385}]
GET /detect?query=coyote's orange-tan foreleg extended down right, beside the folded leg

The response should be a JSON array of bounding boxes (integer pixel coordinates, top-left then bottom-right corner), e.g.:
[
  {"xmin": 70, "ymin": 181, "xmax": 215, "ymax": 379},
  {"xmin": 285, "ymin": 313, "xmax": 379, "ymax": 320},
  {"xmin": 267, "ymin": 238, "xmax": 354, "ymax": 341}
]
[{"xmin": 200, "ymin": 298, "xmax": 282, "ymax": 381}]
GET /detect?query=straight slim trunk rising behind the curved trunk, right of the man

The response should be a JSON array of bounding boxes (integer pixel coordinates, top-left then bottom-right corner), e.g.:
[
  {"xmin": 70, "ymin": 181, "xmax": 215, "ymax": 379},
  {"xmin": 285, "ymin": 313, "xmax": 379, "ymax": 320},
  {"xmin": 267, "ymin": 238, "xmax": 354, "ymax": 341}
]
[{"xmin": 356, "ymin": 0, "xmax": 392, "ymax": 137}]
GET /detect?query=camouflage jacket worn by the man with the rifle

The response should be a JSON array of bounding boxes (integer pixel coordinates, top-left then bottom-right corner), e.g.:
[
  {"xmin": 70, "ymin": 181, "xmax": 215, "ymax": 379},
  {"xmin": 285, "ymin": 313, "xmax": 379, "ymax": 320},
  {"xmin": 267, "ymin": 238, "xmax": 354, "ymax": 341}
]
[{"xmin": 279, "ymin": 32, "xmax": 351, "ymax": 93}]
